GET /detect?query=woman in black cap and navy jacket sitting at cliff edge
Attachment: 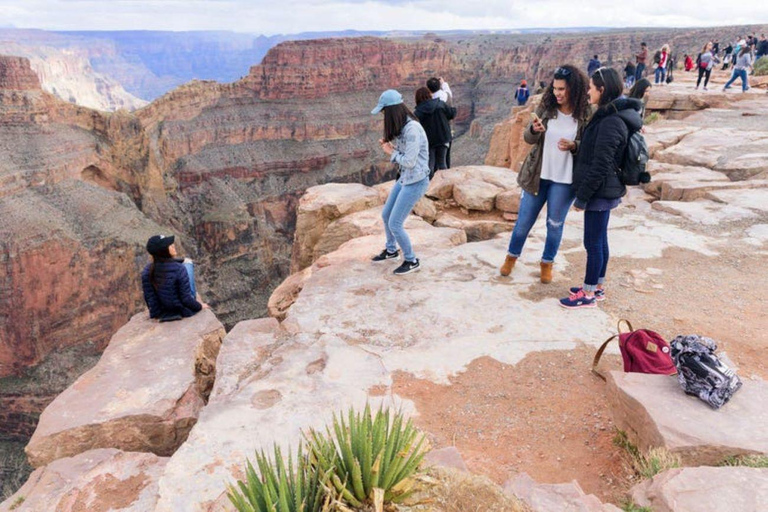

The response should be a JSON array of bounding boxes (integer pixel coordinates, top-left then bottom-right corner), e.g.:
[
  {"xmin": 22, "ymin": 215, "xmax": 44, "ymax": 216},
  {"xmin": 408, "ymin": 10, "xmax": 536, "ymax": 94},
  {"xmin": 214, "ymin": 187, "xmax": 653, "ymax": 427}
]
[{"xmin": 141, "ymin": 235, "xmax": 208, "ymax": 322}]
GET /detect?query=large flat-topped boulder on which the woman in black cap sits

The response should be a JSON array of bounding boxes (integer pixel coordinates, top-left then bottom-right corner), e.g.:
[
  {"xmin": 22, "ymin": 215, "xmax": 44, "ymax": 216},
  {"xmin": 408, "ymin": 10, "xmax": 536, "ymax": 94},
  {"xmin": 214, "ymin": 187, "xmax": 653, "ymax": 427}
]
[{"xmin": 26, "ymin": 309, "xmax": 224, "ymax": 467}]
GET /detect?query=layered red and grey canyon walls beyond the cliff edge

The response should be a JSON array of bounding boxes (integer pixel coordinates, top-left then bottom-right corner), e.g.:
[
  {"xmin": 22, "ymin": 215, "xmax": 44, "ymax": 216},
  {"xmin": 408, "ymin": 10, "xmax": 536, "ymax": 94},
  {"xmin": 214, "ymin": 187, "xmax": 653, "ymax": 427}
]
[{"xmin": 0, "ymin": 27, "xmax": 765, "ymax": 490}]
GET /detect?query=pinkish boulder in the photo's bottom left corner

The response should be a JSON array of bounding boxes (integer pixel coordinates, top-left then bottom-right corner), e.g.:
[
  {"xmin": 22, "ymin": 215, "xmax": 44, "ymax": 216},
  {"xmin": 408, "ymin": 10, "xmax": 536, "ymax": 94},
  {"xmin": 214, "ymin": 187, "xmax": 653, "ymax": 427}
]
[{"xmin": 0, "ymin": 449, "xmax": 168, "ymax": 512}]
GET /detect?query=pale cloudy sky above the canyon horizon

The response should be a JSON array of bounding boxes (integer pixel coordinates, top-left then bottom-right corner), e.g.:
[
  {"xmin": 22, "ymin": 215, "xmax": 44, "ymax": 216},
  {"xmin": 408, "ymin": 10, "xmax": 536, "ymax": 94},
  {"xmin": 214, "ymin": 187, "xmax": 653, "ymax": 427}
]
[{"xmin": 0, "ymin": 0, "xmax": 768, "ymax": 35}]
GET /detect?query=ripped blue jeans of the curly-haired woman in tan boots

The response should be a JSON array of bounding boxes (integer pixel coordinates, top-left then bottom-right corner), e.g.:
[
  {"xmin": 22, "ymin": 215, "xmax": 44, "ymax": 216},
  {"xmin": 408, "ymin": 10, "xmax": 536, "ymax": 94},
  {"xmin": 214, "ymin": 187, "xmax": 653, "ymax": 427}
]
[{"xmin": 507, "ymin": 180, "xmax": 575, "ymax": 263}]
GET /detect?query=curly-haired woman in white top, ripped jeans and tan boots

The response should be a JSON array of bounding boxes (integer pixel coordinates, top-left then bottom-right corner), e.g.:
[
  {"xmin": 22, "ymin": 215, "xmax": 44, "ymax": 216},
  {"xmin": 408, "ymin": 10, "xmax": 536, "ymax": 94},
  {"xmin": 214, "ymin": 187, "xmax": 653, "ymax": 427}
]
[{"xmin": 500, "ymin": 65, "xmax": 590, "ymax": 283}]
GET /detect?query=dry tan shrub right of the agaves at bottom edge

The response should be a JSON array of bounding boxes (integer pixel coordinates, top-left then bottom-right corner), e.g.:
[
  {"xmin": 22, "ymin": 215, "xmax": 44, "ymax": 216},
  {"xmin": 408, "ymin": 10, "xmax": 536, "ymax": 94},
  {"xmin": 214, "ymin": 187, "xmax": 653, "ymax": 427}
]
[{"xmin": 399, "ymin": 468, "xmax": 530, "ymax": 512}]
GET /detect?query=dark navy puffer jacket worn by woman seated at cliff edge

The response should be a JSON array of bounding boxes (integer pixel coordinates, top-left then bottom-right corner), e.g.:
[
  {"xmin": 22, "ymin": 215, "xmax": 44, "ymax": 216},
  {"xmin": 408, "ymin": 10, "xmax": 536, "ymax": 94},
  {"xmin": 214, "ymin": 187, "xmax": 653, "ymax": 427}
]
[{"xmin": 141, "ymin": 259, "xmax": 203, "ymax": 318}]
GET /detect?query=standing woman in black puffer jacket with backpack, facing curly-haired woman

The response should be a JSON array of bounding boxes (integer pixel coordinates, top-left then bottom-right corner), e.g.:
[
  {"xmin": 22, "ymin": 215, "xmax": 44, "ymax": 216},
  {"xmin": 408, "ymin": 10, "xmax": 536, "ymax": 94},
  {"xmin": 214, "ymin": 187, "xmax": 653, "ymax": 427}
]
[{"xmin": 560, "ymin": 67, "xmax": 643, "ymax": 309}]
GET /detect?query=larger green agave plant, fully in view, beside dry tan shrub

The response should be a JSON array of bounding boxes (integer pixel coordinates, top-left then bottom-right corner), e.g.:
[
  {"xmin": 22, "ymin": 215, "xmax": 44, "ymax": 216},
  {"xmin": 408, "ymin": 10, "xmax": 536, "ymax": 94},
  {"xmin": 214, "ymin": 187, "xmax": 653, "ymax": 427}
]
[{"xmin": 307, "ymin": 405, "xmax": 427, "ymax": 507}]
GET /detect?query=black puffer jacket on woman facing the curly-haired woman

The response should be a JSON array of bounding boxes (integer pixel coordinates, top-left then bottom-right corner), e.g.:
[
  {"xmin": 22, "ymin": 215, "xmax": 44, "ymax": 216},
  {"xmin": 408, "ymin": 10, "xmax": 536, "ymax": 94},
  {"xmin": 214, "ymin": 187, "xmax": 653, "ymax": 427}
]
[{"xmin": 572, "ymin": 98, "xmax": 643, "ymax": 208}]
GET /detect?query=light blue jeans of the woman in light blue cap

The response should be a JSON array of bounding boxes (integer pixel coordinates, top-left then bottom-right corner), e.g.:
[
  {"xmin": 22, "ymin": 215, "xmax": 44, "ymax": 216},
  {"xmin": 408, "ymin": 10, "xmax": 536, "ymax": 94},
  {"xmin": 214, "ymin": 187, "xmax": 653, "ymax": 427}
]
[{"xmin": 381, "ymin": 177, "xmax": 429, "ymax": 261}]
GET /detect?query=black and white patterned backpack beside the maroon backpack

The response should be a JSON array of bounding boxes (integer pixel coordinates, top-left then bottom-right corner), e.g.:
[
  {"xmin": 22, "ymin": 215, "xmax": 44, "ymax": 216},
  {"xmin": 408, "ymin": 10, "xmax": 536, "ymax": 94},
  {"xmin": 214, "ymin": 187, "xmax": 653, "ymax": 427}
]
[{"xmin": 670, "ymin": 334, "xmax": 742, "ymax": 409}]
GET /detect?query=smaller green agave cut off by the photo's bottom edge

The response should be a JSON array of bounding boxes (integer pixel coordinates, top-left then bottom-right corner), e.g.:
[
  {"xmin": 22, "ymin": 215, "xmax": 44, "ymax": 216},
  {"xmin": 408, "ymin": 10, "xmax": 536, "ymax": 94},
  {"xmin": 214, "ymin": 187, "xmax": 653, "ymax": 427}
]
[{"xmin": 227, "ymin": 445, "xmax": 325, "ymax": 512}]
